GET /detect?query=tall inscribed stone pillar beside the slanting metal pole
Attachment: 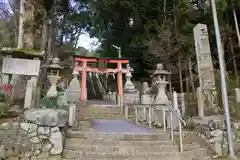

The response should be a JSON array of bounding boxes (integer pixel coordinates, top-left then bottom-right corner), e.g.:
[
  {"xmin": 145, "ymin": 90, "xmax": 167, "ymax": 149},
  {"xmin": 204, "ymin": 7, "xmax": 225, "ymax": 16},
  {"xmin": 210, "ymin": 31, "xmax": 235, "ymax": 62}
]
[{"xmin": 193, "ymin": 24, "xmax": 218, "ymax": 116}]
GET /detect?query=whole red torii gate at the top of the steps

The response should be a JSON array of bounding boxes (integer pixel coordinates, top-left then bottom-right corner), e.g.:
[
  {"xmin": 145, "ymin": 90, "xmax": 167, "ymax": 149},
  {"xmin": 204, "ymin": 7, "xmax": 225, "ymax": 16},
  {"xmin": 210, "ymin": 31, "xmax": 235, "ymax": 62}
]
[{"xmin": 74, "ymin": 57, "xmax": 129, "ymax": 101}]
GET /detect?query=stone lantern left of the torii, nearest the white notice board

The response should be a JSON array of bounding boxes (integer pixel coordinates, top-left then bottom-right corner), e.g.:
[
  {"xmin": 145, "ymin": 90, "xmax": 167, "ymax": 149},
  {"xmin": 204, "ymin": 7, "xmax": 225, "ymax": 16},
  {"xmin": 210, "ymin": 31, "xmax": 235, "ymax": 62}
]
[{"xmin": 46, "ymin": 57, "xmax": 63, "ymax": 97}]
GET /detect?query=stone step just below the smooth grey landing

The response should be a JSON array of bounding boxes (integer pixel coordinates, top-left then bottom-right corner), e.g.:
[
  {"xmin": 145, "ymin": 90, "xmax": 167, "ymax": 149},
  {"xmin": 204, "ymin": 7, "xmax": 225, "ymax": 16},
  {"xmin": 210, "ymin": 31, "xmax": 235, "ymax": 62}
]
[{"xmin": 67, "ymin": 130, "xmax": 172, "ymax": 141}]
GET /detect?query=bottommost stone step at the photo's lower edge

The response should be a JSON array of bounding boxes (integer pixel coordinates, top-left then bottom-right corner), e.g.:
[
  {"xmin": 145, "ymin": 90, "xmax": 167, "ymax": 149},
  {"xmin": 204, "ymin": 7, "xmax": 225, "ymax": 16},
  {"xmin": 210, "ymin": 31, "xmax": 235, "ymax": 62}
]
[{"xmin": 63, "ymin": 149, "xmax": 179, "ymax": 160}]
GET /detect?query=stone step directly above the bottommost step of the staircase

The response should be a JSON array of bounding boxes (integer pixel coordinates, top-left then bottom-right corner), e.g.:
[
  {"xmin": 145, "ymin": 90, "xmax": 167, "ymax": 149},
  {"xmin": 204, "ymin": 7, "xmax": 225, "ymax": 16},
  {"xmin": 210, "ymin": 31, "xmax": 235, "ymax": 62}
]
[{"xmin": 65, "ymin": 138, "xmax": 178, "ymax": 153}]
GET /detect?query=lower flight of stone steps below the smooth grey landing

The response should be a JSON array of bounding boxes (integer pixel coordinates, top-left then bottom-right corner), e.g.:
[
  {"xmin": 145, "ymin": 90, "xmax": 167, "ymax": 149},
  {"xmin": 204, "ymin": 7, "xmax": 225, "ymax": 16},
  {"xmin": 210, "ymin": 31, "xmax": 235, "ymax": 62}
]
[{"xmin": 64, "ymin": 131, "xmax": 179, "ymax": 160}]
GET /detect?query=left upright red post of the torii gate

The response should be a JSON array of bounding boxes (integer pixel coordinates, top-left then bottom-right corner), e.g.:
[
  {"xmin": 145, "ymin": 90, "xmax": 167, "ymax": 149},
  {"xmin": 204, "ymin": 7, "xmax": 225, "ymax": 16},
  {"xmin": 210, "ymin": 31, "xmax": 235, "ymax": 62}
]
[{"xmin": 81, "ymin": 60, "xmax": 87, "ymax": 101}]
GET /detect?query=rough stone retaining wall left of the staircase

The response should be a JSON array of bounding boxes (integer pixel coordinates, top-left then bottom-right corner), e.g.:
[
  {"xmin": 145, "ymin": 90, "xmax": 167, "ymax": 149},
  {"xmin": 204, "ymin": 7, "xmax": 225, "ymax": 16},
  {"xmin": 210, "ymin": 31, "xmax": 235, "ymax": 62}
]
[{"xmin": 0, "ymin": 109, "xmax": 67, "ymax": 160}]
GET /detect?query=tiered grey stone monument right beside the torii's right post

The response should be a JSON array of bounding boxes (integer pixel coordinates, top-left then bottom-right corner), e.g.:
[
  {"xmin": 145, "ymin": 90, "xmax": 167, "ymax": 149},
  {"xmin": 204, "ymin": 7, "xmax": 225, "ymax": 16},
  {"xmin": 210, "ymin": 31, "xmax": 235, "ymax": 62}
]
[{"xmin": 123, "ymin": 64, "xmax": 140, "ymax": 104}]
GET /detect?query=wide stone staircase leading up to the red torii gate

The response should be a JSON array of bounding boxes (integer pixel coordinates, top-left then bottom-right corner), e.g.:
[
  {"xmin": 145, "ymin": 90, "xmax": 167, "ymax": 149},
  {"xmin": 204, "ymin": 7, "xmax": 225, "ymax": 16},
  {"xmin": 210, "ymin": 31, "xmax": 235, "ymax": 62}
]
[{"xmin": 63, "ymin": 105, "xmax": 214, "ymax": 160}]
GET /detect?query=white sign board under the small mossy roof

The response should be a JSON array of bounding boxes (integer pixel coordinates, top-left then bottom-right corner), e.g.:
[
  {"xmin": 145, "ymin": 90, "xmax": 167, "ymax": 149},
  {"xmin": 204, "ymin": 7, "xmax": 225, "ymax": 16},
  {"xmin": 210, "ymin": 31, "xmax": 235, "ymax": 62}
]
[{"xmin": 2, "ymin": 57, "xmax": 41, "ymax": 76}]
